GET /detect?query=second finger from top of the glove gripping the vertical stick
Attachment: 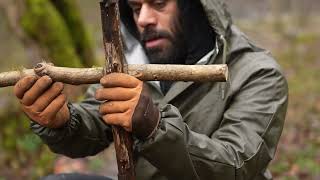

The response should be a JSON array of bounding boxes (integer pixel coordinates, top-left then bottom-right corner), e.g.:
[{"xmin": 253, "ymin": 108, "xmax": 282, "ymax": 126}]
[{"xmin": 96, "ymin": 87, "xmax": 137, "ymax": 101}]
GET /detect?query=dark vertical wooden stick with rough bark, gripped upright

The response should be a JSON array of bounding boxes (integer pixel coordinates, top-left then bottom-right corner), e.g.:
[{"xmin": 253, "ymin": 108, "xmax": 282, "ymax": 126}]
[{"xmin": 100, "ymin": 0, "xmax": 135, "ymax": 180}]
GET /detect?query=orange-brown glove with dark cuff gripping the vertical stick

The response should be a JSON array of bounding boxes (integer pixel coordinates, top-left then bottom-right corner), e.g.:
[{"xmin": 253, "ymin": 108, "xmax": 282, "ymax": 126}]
[{"xmin": 96, "ymin": 73, "xmax": 160, "ymax": 139}]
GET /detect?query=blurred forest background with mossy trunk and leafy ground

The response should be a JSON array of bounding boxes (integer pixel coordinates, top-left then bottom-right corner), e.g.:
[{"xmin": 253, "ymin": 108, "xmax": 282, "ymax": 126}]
[{"xmin": 0, "ymin": 0, "xmax": 320, "ymax": 180}]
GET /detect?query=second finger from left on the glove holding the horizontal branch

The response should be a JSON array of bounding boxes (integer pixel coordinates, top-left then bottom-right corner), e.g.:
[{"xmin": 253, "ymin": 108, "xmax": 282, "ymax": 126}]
[{"xmin": 21, "ymin": 76, "xmax": 52, "ymax": 106}]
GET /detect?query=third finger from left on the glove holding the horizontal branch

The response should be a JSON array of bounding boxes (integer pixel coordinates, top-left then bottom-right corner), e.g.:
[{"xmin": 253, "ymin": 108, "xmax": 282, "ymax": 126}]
[{"xmin": 32, "ymin": 82, "xmax": 64, "ymax": 112}]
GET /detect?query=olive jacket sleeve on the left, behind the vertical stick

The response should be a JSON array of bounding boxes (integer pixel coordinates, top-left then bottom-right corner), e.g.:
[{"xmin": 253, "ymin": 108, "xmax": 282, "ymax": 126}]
[{"xmin": 31, "ymin": 85, "xmax": 112, "ymax": 158}]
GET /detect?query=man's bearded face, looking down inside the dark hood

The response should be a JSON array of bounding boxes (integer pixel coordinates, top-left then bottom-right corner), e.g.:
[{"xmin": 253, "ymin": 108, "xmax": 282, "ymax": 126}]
[{"xmin": 128, "ymin": 0, "xmax": 182, "ymax": 64}]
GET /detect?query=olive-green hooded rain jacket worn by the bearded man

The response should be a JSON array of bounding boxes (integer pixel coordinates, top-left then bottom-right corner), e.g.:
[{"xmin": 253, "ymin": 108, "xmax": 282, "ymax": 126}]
[{"xmin": 31, "ymin": 0, "xmax": 288, "ymax": 180}]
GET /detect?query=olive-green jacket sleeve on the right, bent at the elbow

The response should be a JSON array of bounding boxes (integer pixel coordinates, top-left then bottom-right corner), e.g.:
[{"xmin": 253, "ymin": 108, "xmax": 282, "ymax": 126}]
[{"xmin": 138, "ymin": 68, "xmax": 287, "ymax": 180}]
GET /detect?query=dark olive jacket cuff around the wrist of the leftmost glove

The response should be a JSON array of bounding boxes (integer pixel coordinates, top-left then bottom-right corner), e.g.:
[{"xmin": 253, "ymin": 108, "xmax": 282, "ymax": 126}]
[{"xmin": 31, "ymin": 103, "xmax": 81, "ymax": 144}]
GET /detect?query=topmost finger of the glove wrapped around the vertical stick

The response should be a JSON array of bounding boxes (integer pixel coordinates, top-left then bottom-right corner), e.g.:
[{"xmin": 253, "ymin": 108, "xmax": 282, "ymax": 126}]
[{"xmin": 100, "ymin": 73, "xmax": 141, "ymax": 88}]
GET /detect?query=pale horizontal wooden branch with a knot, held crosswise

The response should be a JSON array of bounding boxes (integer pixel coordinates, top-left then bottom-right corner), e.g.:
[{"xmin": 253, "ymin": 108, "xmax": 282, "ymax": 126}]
[{"xmin": 0, "ymin": 63, "xmax": 228, "ymax": 87}]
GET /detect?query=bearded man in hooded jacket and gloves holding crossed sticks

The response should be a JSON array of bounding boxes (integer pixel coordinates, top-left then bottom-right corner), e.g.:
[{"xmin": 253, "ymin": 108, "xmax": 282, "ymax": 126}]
[{"xmin": 15, "ymin": 0, "xmax": 288, "ymax": 180}]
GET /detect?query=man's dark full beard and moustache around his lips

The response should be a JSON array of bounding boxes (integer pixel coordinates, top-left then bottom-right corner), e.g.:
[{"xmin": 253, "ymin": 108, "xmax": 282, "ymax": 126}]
[{"xmin": 140, "ymin": 21, "xmax": 187, "ymax": 64}]
